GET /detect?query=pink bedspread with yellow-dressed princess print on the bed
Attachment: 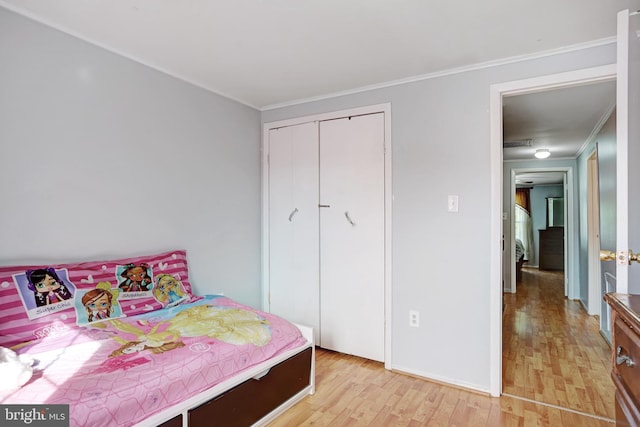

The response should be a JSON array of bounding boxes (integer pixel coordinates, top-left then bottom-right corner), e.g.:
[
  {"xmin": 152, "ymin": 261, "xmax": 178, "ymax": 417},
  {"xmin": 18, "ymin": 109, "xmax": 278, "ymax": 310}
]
[{"xmin": 0, "ymin": 295, "xmax": 305, "ymax": 426}]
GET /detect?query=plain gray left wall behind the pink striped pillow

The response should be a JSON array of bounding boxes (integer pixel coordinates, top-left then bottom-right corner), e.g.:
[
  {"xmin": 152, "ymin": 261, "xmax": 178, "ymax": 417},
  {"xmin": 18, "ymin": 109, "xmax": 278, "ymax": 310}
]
[{"xmin": 0, "ymin": 8, "xmax": 261, "ymax": 306}]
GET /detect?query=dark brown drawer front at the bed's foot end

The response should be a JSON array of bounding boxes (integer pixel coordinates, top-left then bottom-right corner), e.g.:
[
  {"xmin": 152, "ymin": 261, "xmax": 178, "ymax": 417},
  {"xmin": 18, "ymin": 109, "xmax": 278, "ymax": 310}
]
[{"xmin": 189, "ymin": 348, "xmax": 312, "ymax": 427}]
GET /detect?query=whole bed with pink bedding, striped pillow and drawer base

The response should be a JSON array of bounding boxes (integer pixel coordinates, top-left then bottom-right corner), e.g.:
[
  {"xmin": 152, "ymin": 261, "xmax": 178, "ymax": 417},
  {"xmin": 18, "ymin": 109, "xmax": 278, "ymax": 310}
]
[{"xmin": 0, "ymin": 251, "xmax": 315, "ymax": 427}]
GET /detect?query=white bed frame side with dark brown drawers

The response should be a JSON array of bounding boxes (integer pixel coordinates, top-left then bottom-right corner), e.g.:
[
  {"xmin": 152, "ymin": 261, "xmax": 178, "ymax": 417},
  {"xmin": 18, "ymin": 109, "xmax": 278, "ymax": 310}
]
[{"xmin": 136, "ymin": 325, "xmax": 315, "ymax": 427}]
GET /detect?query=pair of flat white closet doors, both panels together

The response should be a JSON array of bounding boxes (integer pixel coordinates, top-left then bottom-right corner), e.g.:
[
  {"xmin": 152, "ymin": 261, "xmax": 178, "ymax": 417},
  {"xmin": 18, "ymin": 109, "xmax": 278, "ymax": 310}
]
[{"xmin": 268, "ymin": 113, "xmax": 385, "ymax": 361}]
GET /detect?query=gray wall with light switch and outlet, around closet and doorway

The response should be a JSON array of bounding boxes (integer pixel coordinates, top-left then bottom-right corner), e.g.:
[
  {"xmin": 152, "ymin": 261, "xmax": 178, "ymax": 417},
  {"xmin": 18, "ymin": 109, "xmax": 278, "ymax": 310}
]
[{"xmin": 262, "ymin": 45, "xmax": 615, "ymax": 390}]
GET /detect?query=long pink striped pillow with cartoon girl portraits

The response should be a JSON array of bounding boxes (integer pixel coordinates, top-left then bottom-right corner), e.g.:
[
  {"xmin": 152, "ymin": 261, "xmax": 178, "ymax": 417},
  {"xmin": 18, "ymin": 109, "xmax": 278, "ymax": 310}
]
[{"xmin": 0, "ymin": 250, "xmax": 193, "ymax": 347}]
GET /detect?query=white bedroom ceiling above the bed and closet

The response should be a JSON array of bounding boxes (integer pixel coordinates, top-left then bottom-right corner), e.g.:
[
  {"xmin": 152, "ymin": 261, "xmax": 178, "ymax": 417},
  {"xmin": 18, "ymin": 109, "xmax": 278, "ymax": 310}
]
[{"xmin": 0, "ymin": 0, "xmax": 640, "ymax": 109}]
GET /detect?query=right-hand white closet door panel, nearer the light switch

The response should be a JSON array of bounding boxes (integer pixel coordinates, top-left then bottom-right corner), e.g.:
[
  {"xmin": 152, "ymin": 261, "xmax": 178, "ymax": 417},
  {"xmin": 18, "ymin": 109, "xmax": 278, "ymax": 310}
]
[{"xmin": 320, "ymin": 113, "xmax": 385, "ymax": 361}]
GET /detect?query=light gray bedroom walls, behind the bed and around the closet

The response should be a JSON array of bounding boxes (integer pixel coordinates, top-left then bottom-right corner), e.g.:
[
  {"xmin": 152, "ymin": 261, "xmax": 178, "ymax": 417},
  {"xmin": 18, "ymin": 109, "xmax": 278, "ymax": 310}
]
[{"xmin": 0, "ymin": 4, "xmax": 615, "ymax": 390}]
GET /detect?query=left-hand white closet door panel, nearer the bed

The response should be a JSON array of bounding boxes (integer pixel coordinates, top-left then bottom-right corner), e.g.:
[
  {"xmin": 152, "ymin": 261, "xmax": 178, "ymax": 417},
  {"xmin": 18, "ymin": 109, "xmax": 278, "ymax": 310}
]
[{"xmin": 268, "ymin": 122, "xmax": 320, "ymax": 341}]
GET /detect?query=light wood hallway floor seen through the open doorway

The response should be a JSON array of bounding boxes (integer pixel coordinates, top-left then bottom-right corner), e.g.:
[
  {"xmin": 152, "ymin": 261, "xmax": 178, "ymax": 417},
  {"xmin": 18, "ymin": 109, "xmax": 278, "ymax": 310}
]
[{"xmin": 502, "ymin": 268, "xmax": 615, "ymax": 419}]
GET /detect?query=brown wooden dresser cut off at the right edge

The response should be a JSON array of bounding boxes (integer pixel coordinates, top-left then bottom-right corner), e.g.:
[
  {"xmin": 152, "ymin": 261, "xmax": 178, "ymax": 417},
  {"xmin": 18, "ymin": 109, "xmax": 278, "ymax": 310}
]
[{"xmin": 604, "ymin": 293, "xmax": 640, "ymax": 426}]
